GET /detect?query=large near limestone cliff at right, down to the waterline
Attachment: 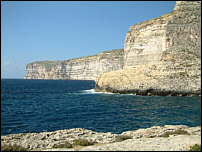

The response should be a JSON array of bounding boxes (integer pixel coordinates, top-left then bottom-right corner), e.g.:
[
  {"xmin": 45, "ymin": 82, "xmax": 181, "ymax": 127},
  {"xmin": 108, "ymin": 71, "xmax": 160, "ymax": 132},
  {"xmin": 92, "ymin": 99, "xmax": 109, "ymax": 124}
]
[{"xmin": 95, "ymin": 1, "xmax": 201, "ymax": 95}]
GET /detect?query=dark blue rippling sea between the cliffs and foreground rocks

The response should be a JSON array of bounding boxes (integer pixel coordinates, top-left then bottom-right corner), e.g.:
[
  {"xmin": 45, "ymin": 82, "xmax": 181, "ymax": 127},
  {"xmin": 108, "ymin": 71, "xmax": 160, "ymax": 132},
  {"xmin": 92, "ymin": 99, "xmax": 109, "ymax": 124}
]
[{"xmin": 1, "ymin": 79, "xmax": 201, "ymax": 135}]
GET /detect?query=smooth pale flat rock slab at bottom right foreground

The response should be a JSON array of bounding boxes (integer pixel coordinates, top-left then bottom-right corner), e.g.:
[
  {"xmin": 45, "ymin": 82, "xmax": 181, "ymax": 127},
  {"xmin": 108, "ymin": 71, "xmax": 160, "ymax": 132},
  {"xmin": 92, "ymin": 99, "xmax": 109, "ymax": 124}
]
[{"xmin": 78, "ymin": 135, "xmax": 201, "ymax": 151}]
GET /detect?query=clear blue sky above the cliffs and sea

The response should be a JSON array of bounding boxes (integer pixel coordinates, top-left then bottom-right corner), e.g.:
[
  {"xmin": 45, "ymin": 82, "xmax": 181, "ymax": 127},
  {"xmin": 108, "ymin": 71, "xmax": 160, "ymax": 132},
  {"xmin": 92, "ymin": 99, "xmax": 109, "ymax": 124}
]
[{"xmin": 1, "ymin": 1, "xmax": 175, "ymax": 78}]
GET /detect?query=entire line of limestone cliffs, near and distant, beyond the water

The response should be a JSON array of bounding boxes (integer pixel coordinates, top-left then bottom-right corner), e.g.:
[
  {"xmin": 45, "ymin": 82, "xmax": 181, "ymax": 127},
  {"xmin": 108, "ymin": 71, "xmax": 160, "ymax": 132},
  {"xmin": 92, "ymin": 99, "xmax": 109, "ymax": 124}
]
[{"xmin": 25, "ymin": 1, "xmax": 201, "ymax": 96}]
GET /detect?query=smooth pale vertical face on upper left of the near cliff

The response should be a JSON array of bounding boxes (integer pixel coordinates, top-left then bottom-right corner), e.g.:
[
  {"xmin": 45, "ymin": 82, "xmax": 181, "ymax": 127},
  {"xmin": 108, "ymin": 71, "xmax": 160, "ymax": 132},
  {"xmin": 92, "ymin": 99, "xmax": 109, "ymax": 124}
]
[{"xmin": 124, "ymin": 12, "xmax": 173, "ymax": 68}]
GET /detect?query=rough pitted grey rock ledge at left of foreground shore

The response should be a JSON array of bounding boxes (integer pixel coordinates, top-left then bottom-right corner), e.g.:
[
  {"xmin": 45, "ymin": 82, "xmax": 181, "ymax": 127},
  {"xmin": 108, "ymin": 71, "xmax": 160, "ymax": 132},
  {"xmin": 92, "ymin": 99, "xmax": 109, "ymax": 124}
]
[{"xmin": 1, "ymin": 128, "xmax": 116, "ymax": 150}]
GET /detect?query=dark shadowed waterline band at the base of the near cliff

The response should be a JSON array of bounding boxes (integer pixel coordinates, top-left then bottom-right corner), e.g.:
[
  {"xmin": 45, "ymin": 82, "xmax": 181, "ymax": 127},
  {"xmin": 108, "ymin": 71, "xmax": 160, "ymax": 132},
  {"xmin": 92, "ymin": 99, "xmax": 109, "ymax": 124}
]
[{"xmin": 94, "ymin": 84, "xmax": 201, "ymax": 96}]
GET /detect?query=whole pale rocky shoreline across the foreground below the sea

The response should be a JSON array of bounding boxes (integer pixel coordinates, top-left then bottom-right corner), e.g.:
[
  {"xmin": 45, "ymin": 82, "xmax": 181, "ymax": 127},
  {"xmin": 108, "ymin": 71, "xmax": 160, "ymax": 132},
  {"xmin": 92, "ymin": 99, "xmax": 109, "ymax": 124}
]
[{"xmin": 1, "ymin": 125, "xmax": 201, "ymax": 151}]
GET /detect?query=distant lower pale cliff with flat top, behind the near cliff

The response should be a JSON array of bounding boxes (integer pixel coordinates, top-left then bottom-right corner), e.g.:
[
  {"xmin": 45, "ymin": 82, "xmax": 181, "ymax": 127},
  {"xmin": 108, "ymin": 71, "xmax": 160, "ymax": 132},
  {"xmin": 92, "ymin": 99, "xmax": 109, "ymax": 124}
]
[{"xmin": 25, "ymin": 49, "xmax": 124, "ymax": 80}]
